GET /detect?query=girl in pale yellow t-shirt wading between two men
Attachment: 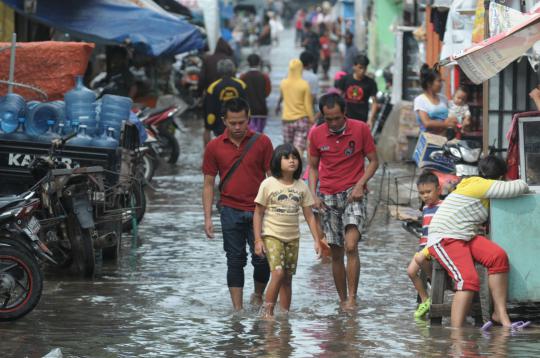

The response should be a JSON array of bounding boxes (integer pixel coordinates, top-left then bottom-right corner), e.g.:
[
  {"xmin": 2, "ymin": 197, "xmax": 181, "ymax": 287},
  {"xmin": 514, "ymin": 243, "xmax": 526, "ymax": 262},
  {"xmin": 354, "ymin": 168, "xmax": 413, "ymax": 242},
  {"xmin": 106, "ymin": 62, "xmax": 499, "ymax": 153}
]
[{"xmin": 253, "ymin": 144, "xmax": 322, "ymax": 318}]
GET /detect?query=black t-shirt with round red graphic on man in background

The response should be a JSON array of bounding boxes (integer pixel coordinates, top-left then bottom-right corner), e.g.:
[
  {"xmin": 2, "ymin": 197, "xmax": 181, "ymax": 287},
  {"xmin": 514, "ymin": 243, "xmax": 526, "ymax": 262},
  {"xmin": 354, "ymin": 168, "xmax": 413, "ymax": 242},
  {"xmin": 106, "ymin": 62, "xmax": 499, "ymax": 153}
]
[{"xmin": 336, "ymin": 74, "xmax": 377, "ymax": 122}]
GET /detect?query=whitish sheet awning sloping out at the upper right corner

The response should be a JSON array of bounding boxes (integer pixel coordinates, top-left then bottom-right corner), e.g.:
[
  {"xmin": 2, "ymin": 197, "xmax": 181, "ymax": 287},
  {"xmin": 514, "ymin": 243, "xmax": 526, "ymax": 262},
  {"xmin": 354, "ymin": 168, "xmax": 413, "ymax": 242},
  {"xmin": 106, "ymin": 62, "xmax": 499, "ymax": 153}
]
[{"xmin": 441, "ymin": 4, "xmax": 540, "ymax": 84}]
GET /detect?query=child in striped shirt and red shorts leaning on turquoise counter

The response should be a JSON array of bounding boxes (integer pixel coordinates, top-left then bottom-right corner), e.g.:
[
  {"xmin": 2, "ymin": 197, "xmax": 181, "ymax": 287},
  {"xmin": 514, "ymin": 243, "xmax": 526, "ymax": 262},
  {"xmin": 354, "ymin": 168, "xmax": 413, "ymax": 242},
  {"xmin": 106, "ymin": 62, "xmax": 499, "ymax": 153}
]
[{"xmin": 427, "ymin": 155, "xmax": 529, "ymax": 327}]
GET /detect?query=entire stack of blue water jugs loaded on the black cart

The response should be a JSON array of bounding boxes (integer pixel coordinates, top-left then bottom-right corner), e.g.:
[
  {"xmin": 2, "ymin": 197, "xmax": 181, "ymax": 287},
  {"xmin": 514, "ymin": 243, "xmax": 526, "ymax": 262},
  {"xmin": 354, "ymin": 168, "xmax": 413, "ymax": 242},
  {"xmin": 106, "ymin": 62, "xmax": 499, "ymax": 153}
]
[{"xmin": 0, "ymin": 76, "xmax": 133, "ymax": 148}]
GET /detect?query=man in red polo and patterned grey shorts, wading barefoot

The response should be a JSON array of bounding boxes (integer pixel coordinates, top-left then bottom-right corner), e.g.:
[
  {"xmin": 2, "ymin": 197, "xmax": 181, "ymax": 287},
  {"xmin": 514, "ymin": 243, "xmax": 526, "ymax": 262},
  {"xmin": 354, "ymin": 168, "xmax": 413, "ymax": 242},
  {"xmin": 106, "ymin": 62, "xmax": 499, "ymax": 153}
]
[{"xmin": 309, "ymin": 93, "xmax": 379, "ymax": 309}]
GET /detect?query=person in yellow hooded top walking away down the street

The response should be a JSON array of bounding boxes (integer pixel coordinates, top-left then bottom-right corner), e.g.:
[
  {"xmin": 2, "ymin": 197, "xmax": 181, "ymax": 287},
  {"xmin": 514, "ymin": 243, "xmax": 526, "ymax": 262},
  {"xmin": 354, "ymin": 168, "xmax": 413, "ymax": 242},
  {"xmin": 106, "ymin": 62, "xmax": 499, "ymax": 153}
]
[{"xmin": 276, "ymin": 59, "xmax": 315, "ymax": 156}]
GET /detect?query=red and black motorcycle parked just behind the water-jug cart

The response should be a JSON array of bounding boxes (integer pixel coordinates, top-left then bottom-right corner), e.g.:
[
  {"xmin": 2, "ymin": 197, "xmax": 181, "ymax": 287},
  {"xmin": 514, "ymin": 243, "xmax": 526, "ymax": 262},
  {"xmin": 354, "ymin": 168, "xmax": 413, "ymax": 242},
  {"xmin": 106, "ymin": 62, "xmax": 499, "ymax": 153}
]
[{"xmin": 137, "ymin": 106, "xmax": 180, "ymax": 164}]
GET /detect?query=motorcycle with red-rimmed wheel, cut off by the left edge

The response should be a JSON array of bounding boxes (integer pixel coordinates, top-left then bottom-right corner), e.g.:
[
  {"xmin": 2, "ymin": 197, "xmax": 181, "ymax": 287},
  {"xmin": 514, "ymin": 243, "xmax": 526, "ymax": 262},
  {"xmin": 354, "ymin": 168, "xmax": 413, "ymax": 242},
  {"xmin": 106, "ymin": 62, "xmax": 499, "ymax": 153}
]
[{"xmin": 0, "ymin": 192, "xmax": 56, "ymax": 321}]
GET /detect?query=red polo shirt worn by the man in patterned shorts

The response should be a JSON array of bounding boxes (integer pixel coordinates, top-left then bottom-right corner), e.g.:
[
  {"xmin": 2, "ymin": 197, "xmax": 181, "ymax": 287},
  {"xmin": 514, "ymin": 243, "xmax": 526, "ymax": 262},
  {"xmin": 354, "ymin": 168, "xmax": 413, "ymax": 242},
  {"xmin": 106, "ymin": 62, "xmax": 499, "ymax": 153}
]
[{"xmin": 309, "ymin": 119, "xmax": 376, "ymax": 194}]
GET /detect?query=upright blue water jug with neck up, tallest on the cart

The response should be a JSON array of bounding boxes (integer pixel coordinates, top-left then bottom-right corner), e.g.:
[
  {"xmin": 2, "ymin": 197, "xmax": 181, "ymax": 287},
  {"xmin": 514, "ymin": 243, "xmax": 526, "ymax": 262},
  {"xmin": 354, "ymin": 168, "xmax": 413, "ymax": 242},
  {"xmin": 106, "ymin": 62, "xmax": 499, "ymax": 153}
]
[{"xmin": 64, "ymin": 76, "xmax": 97, "ymax": 134}]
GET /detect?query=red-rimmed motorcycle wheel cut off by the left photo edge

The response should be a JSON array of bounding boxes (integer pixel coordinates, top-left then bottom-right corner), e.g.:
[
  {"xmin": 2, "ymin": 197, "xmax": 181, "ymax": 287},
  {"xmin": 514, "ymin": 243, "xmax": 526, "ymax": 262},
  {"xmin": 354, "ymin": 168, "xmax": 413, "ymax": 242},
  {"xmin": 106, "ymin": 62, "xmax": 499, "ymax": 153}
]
[{"xmin": 0, "ymin": 246, "xmax": 43, "ymax": 321}]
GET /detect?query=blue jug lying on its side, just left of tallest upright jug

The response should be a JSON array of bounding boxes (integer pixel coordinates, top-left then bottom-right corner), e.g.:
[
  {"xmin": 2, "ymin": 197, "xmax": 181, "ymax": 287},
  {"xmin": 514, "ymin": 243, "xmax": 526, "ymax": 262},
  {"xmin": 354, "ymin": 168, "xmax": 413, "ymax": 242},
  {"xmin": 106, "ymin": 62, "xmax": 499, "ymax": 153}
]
[{"xmin": 25, "ymin": 102, "xmax": 64, "ymax": 137}]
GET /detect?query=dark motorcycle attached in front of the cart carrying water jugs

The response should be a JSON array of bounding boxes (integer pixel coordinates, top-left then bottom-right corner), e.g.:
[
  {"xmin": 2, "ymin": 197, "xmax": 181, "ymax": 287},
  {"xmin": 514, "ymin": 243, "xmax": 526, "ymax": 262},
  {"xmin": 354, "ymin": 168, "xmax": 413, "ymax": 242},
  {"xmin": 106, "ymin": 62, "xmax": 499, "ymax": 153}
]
[{"xmin": 29, "ymin": 134, "xmax": 117, "ymax": 277}]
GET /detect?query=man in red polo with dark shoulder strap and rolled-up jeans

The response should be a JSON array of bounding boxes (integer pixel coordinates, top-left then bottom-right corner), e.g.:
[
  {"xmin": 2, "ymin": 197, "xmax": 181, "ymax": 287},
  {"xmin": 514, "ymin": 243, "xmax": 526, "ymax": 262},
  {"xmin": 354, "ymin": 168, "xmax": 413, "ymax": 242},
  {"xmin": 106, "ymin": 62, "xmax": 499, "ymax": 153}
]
[{"xmin": 202, "ymin": 98, "xmax": 273, "ymax": 310}]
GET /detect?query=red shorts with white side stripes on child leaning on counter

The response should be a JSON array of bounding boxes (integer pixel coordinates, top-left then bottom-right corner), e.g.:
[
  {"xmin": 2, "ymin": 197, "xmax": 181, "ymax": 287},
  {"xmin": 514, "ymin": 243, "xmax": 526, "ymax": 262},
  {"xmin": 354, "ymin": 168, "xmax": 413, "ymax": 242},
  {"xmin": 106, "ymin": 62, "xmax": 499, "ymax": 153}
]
[{"xmin": 429, "ymin": 236, "xmax": 510, "ymax": 291}]
